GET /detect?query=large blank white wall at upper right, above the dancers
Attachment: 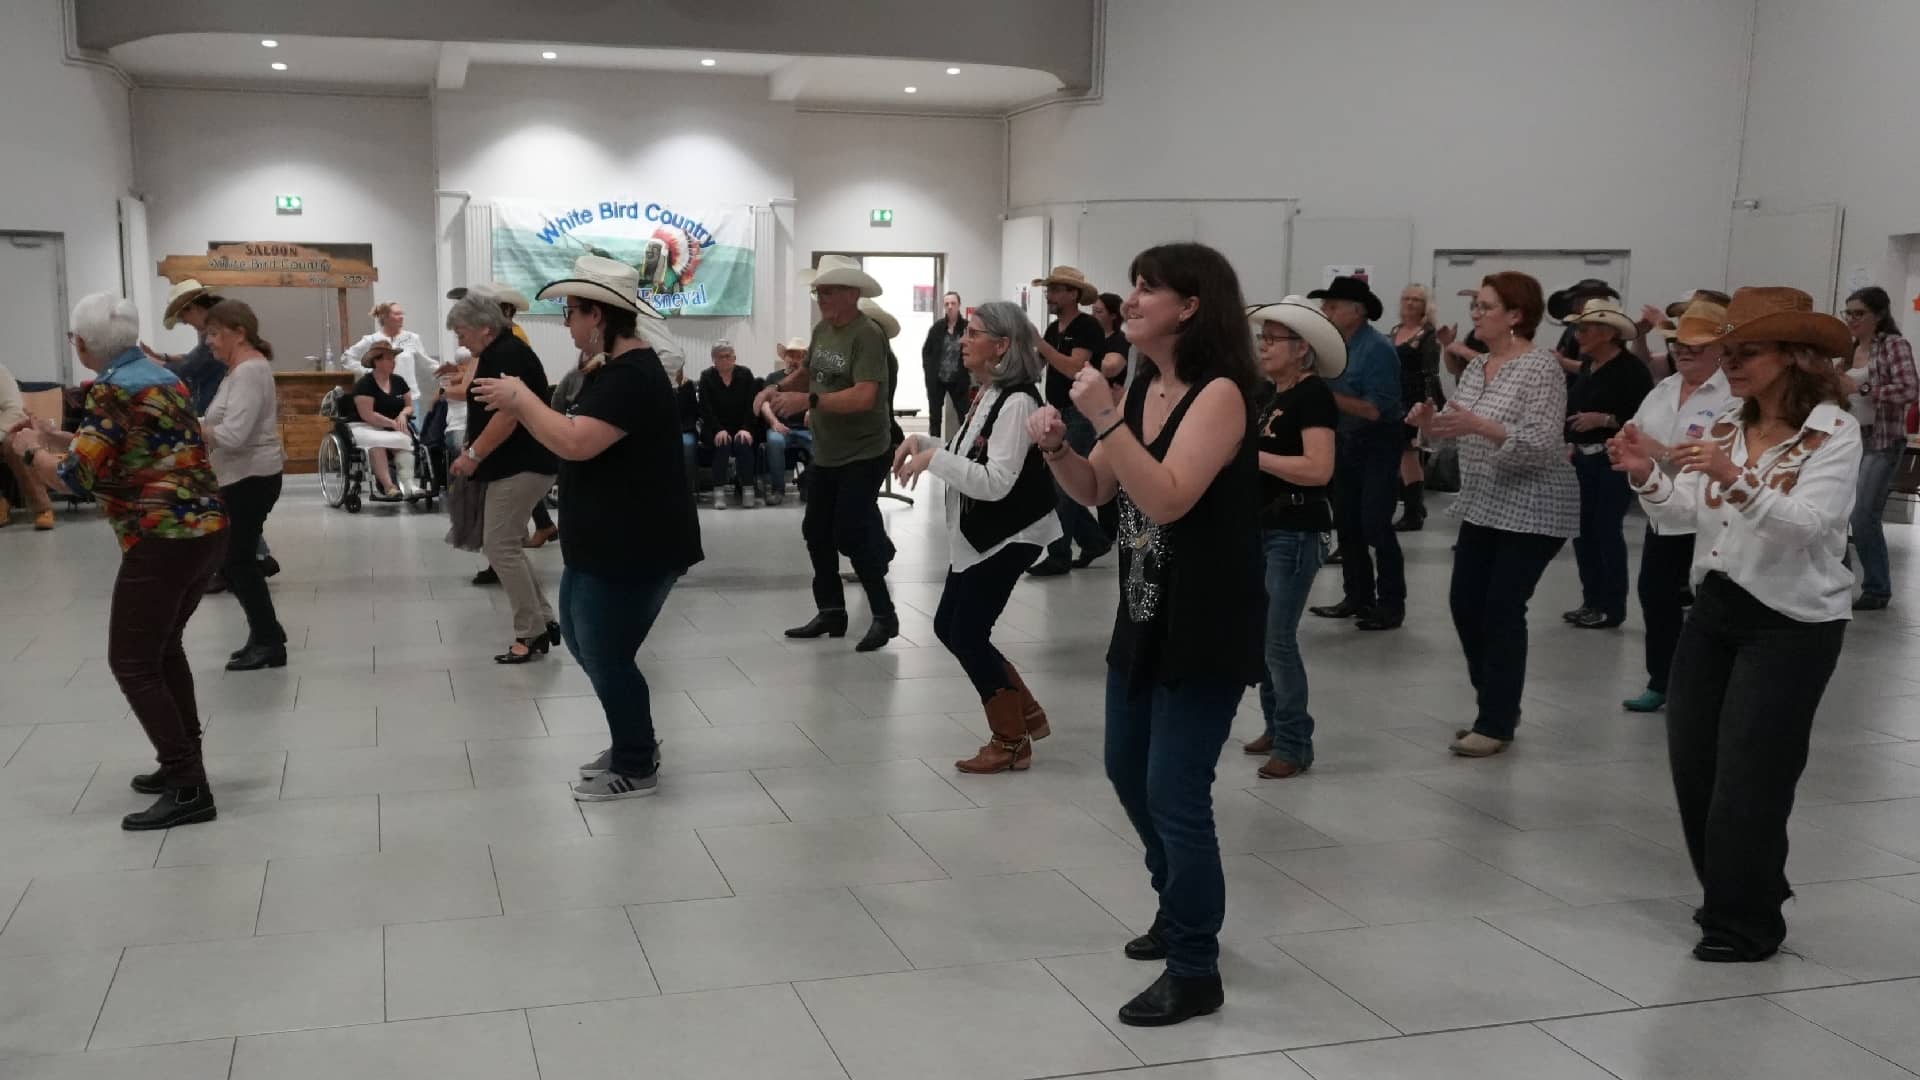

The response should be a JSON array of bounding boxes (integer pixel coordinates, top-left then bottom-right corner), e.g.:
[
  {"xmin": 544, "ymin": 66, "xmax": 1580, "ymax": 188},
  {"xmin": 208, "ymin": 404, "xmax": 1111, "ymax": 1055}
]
[{"xmin": 1010, "ymin": 0, "xmax": 1758, "ymax": 315}]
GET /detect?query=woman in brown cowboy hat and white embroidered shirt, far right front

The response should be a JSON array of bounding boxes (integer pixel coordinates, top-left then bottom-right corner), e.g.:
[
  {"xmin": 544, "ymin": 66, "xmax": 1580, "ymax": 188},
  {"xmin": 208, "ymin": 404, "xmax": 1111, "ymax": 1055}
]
[{"xmin": 1607, "ymin": 288, "xmax": 1860, "ymax": 963}]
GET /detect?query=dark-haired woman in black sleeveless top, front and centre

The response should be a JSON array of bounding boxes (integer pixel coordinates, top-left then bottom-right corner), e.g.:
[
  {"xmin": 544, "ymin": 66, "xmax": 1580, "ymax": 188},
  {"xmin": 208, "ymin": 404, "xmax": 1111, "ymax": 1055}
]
[{"xmin": 1029, "ymin": 244, "xmax": 1265, "ymax": 1026}]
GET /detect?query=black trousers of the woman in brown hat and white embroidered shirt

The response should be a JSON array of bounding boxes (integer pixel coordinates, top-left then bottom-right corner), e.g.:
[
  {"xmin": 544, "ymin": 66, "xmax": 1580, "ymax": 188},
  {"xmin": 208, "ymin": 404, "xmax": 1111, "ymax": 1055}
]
[{"xmin": 1667, "ymin": 573, "xmax": 1847, "ymax": 951}]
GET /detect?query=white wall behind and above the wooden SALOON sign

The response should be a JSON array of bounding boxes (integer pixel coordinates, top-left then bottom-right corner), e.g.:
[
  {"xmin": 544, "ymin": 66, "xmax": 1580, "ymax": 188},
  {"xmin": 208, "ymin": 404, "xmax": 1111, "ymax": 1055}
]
[{"xmin": 134, "ymin": 88, "xmax": 436, "ymax": 367}]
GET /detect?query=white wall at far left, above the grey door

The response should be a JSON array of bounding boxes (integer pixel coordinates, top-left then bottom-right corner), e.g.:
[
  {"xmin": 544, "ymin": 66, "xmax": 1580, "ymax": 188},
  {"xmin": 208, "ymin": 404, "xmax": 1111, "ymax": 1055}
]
[{"xmin": 0, "ymin": 0, "xmax": 132, "ymax": 319}]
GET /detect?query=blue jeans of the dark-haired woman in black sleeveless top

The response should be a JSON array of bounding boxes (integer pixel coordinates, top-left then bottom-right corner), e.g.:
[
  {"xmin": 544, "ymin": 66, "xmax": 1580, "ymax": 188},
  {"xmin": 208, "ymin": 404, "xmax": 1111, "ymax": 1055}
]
[{"xmin": 1106, "ymin": 667, "xmax": 1246, "ymax": 976}]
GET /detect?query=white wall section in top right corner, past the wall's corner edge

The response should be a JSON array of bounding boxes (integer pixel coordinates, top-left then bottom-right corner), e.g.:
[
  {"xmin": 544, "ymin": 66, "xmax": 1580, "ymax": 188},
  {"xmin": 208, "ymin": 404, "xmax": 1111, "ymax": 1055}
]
[{"xmin": 1740, "ymin": 0, "xmax": 1920, "ymax": 309}]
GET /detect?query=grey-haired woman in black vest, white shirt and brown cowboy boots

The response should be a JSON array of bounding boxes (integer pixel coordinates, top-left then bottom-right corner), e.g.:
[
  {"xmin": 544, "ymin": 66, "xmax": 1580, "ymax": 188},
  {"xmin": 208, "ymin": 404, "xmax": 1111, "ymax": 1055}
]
[{"xmin": 893, "ymin": 300, "xmax": 1060, "ymax": 773}]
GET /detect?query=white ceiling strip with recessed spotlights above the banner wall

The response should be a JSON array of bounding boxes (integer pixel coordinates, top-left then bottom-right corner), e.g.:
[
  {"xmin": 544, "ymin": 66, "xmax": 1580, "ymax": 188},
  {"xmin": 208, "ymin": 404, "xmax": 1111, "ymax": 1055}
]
[{"xmin": 111, "ymin": 35, "xmax": 1060, "ymax": 111}]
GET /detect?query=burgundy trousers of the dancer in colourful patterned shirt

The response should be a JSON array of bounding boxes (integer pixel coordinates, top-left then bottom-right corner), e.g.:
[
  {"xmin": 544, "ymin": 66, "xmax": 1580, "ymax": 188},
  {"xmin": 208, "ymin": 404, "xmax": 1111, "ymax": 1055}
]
[{"xmin": 108, "ymin": 530, "xmax": 227, "ymax": 788}]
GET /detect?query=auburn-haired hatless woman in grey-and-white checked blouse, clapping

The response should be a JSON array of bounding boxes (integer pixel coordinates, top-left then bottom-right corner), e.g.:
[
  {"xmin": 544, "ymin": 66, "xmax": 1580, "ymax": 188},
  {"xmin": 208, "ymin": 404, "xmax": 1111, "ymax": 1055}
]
[{"xmin": 1407, "ymin": 271, "xmax": 1580, "ymax": 757}]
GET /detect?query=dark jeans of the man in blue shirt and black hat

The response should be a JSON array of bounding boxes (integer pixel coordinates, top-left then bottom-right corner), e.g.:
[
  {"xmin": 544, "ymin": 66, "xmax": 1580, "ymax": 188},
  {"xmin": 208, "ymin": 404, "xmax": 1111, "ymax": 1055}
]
[{"xmin": 1332, "ymin": 425, "xmax": 1407, "ymax": 611}]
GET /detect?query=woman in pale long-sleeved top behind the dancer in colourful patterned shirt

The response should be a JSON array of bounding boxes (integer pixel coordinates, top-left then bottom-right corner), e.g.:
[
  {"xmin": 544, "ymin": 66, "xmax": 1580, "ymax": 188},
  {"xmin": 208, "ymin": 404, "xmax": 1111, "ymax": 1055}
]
[{"xmin": 200, "ymin": 300, "xmax": 286, "ymax": 671}]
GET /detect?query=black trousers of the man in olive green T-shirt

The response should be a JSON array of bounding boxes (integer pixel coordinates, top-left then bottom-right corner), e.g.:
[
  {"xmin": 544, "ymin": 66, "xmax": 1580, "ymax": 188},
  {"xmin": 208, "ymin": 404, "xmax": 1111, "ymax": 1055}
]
[{"xmin": 801, "ymin": 454, "xmax": 893, "ymax": 617}]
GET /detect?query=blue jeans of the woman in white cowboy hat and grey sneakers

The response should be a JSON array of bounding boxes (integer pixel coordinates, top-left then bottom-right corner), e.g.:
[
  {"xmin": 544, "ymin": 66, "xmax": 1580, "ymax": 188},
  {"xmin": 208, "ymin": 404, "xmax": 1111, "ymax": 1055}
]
[{"xmin": 561, "ymin": 567, "xmax": 680, "ymax": 776}]
